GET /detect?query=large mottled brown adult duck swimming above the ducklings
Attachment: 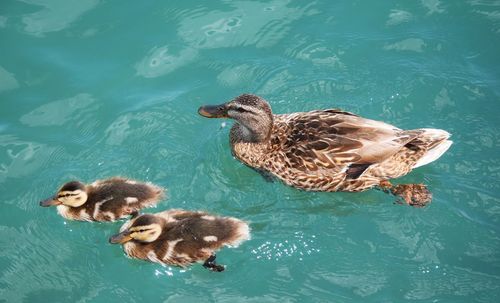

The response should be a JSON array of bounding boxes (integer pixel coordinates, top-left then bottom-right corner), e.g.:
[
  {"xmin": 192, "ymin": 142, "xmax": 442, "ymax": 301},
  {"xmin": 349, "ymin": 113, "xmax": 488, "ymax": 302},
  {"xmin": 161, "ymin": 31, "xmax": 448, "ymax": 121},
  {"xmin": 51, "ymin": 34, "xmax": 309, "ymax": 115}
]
[{"xmin": 198, "ymin": 94, "xmax": 452, "ymax": 206}]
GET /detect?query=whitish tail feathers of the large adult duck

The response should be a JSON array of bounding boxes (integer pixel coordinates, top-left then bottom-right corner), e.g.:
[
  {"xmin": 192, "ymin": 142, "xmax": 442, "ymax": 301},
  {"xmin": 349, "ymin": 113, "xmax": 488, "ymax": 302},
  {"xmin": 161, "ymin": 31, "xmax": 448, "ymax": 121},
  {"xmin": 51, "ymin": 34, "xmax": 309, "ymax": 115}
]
[{"xmin": 409, "ymin": 128, "xmax": 453, "ymax": 168}]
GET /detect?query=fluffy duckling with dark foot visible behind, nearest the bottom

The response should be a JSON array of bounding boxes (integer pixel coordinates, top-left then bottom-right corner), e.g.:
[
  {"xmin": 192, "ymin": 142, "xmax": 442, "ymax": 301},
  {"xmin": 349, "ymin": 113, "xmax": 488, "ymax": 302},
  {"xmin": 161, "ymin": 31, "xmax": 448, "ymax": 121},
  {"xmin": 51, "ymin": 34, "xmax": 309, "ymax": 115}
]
[{"xmin": 109, "ymin": 209, "xmax": 250, "ymax": 272}]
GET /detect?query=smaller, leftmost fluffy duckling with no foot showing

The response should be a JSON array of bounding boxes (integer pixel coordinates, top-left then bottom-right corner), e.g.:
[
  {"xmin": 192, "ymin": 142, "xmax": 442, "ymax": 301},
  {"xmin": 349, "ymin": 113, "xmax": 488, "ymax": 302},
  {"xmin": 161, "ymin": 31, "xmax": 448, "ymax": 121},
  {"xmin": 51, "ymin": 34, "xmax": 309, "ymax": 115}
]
[{"xmin": 40, "ymin": 177, "xmax": 165, "ymax": 221}]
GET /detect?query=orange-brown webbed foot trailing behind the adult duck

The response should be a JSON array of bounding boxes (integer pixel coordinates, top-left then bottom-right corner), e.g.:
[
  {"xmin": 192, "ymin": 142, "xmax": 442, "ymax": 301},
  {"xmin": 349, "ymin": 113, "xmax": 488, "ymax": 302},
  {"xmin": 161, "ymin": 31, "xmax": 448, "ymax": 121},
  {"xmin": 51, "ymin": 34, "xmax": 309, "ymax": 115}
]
[{"xmin": 379, "ymin": 181, "xmax": 432, "ymax": 207}]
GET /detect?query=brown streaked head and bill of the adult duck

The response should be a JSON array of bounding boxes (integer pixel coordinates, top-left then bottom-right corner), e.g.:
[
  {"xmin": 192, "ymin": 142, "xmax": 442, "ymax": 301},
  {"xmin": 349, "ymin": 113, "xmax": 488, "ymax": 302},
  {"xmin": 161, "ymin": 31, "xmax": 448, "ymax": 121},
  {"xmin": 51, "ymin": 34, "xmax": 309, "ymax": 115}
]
[{"xmin": 198, "ymin": 94, "xmax": 273, "ymax": 142}]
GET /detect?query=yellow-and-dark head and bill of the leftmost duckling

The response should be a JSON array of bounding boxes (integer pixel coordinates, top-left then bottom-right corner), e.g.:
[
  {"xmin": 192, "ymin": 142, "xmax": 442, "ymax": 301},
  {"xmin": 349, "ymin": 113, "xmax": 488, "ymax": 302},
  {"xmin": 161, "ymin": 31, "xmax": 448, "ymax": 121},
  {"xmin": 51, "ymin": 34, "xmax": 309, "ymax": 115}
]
[{"xmin": 40, "ymin": 181, "xmax": 88, "ymax": 207}]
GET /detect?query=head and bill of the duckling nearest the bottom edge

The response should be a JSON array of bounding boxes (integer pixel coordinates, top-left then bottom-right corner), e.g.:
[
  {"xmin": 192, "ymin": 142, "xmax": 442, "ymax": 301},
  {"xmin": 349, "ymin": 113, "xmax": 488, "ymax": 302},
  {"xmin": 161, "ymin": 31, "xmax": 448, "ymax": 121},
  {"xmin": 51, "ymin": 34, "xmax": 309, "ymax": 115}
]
[{"xmin": 109, "ymin": 214, "xmax": 165, "ymax": 244}]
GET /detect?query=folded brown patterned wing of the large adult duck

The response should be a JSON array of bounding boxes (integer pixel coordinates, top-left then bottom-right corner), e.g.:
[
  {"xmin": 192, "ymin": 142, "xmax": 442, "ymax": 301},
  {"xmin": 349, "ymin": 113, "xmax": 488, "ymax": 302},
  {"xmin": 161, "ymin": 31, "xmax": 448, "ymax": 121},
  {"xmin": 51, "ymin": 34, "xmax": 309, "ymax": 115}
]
[{"xmin": 278, "ymin": 109, "xmax": 419, "ymax": 175}]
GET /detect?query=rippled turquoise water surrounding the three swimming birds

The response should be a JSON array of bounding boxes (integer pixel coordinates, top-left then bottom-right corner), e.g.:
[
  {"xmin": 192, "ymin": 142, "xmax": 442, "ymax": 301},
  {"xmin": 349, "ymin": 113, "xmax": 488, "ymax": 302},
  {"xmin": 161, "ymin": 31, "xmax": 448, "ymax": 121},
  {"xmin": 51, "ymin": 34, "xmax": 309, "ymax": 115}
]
[{"xmin": 0, "ymin": 0, "xmax": 500, "ymax": 302}]
